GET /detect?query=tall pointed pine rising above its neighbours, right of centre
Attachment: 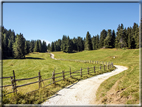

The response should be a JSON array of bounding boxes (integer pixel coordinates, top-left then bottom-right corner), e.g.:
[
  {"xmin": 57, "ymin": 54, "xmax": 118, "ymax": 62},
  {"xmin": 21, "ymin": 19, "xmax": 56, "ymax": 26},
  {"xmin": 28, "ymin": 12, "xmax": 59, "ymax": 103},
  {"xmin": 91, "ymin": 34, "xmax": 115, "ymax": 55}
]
[{"xmin": 85, "ymin": 32, "xmax": 92, "ymax": 50}]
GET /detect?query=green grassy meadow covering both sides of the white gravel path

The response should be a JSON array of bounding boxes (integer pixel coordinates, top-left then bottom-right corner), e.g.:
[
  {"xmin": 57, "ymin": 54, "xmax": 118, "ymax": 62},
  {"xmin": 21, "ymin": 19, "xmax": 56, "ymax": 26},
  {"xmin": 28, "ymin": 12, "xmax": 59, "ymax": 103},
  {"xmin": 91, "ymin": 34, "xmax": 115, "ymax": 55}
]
[{"xmin": 3, "ymin": 49, "xmax": 139, "ymax": 104}]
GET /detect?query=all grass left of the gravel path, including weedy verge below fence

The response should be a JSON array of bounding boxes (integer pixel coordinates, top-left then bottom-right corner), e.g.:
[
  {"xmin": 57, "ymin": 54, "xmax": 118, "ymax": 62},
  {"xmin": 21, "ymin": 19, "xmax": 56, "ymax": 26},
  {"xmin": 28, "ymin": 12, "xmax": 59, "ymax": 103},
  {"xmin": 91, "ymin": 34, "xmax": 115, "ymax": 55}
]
[{"xmin": 3, "ymin": 53, "xmax": 115, "ymax": 104}]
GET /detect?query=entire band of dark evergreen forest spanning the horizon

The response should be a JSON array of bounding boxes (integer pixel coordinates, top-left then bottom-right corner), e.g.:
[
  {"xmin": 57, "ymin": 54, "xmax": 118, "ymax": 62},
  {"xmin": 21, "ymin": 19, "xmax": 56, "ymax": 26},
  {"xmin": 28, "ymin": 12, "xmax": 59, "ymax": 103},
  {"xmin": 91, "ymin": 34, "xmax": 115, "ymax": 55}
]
[{"xmin": 0, "ymin": 23, "xmax": 140, "ymax": 59}]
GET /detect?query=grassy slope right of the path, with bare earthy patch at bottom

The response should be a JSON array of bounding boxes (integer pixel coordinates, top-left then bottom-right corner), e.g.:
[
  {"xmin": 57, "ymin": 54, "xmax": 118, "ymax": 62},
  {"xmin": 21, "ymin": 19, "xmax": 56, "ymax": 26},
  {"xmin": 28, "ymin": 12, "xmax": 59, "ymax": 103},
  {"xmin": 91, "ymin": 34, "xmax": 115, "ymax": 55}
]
[{"xmin": 53, "ymin": 49, "xmax": 139, "ymax": 104}]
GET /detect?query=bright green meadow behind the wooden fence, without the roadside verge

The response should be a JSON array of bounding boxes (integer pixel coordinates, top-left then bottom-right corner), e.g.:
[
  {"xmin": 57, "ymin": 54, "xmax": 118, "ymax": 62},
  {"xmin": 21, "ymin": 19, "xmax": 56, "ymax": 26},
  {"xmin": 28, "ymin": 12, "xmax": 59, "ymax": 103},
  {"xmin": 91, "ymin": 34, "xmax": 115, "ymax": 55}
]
[{"xmin": 3, "ymin": 53, "xmax": 99, "ymax": 93}]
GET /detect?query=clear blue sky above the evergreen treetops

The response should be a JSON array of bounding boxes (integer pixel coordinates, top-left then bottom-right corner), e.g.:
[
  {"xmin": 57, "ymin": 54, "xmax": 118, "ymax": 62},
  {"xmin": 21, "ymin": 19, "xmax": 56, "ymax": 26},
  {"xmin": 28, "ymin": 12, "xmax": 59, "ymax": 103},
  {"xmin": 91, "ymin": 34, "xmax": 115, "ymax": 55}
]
[{"xmin": 3, "ymin": 3, "xmax": 140, "ymax": 42}]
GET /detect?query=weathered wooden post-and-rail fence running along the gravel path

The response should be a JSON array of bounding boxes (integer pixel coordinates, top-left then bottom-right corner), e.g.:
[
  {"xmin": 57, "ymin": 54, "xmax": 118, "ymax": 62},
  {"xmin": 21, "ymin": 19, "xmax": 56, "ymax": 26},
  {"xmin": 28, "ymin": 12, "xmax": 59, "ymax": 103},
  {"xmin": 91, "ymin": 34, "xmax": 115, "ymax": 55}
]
[{"xmin": 0, "ymin": 59, "xmax": 113, "ymax": 95}]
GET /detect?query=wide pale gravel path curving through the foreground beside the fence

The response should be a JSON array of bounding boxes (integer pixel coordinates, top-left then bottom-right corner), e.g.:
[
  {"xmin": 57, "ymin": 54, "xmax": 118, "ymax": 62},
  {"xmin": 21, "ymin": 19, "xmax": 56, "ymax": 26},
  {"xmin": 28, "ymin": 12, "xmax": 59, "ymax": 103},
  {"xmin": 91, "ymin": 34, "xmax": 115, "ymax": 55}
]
[{"xmin": 42, "ymin": 65, "xmax": 128, "ymax": 105}]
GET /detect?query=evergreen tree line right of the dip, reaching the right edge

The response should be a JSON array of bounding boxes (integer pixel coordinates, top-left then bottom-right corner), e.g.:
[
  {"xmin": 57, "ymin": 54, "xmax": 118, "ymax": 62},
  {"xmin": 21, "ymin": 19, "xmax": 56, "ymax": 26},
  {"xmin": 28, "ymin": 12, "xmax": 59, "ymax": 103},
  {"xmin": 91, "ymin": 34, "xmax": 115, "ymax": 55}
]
[{"xmin": 47, "ymin": 23, "xmax": 140, "ymax": 53}]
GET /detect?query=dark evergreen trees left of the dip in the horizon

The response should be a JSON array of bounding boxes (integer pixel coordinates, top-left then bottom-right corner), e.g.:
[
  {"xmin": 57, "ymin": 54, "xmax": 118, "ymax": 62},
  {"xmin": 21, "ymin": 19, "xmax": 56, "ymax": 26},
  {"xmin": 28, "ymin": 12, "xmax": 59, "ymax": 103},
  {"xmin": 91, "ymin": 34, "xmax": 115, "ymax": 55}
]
[{"xmin": 0, "ymin": 27, "xmax": 47, "ymax": 59}]
